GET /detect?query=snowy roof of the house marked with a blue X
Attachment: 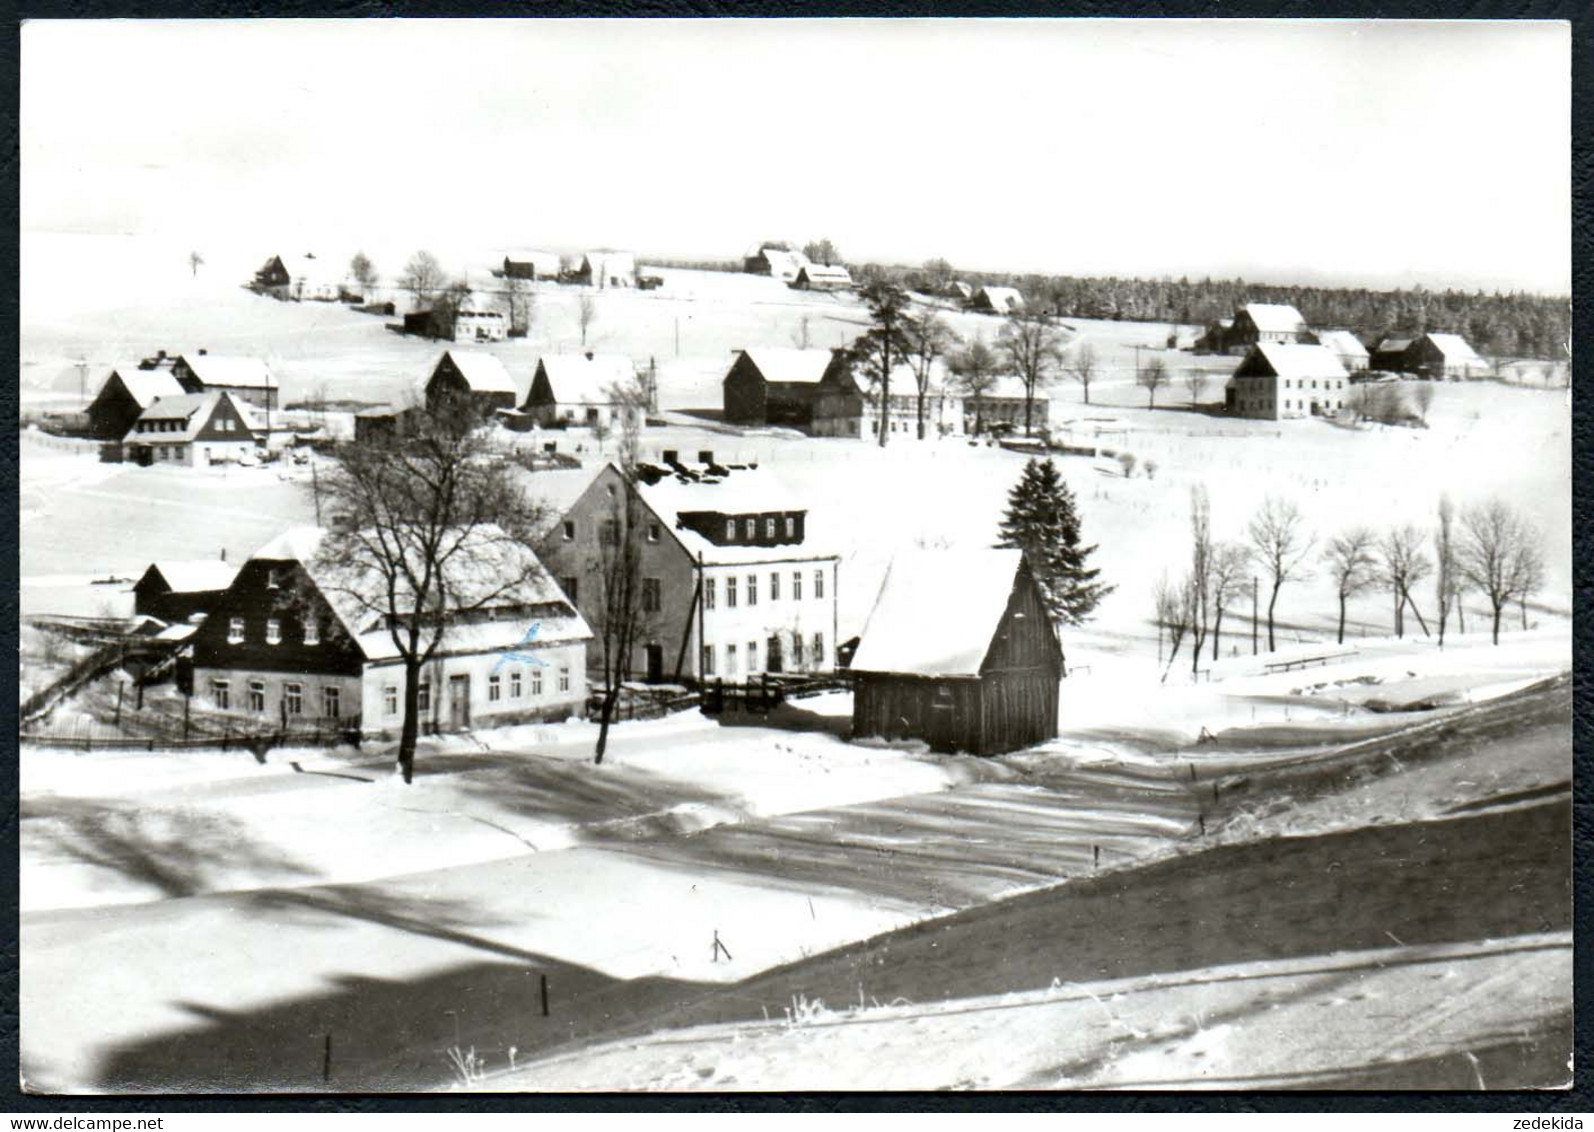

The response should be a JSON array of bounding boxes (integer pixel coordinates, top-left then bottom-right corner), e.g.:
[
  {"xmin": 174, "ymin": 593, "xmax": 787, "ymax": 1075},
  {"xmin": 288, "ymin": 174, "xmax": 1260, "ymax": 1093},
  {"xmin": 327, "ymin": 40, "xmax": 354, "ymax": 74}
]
[{"xmin": 250, "ymin": 523, "xmax": 591, "ymax": 660}]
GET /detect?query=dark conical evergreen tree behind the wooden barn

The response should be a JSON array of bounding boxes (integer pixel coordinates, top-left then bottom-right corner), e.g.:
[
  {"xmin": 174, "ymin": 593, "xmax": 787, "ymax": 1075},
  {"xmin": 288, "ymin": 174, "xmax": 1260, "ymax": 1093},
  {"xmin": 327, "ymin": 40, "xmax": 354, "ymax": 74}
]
[{"xmin": 996, "ymin": 459, "xmax": 1116, "ymax": 625}]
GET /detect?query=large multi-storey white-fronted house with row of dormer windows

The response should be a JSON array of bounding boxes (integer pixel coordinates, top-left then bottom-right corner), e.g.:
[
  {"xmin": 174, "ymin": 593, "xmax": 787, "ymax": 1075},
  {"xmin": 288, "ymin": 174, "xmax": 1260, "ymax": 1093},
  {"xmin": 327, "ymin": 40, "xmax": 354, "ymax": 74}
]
[{"xmin": 539, "ymin": 453, "xmax": 838, "ymax": 682}]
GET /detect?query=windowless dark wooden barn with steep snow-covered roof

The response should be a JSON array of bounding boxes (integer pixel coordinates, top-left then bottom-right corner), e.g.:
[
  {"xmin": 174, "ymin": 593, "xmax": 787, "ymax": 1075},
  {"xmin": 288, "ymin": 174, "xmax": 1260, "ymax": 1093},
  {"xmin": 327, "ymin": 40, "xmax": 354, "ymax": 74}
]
[{"xmin": 851, "ymin": 548, "xmax": 1063, "ymax": 754}]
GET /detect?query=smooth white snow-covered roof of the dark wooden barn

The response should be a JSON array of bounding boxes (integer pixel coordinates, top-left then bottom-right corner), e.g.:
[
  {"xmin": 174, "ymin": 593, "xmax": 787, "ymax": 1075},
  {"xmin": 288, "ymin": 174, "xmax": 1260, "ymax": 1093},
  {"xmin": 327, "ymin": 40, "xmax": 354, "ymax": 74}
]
[{"xmin": 853, "ymin": 548, "xmax": 1023, "ymax": 676}]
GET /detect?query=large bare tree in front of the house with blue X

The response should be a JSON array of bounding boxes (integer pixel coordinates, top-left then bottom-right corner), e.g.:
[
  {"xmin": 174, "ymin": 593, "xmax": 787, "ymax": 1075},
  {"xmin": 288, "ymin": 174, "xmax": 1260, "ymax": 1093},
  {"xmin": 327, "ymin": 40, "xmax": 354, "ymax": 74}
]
[{"xmin": 317, "ymin": 403, "xmax": 545, "ymax": 783}]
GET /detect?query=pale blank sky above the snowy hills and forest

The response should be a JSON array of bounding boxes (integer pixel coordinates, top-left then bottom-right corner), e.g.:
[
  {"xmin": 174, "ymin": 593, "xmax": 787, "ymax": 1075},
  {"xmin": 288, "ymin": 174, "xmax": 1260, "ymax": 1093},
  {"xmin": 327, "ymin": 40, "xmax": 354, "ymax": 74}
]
[{"xmin": 21, "ymin": 19, "xmax": 1572, "ymax": 293}]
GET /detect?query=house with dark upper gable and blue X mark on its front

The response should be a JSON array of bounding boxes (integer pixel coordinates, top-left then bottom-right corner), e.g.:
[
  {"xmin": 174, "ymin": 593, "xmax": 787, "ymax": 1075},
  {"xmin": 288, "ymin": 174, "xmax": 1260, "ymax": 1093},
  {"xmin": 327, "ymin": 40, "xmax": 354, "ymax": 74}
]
[{"xmin": 191, "ymin": 526, "xmax": 591, "ymax": 737}]
